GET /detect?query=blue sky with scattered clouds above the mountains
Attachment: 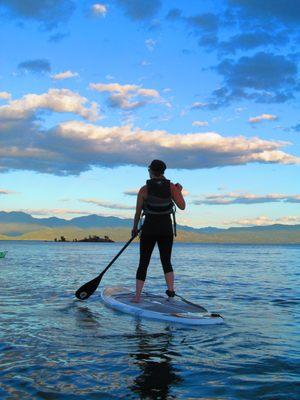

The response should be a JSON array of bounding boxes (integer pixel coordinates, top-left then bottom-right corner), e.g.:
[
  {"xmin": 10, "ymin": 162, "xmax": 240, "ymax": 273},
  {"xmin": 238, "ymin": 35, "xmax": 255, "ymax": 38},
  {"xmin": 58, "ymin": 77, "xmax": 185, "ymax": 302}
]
[{"xmin": 0, "ymin": 0, "xmax": 300, "ymax": 227}]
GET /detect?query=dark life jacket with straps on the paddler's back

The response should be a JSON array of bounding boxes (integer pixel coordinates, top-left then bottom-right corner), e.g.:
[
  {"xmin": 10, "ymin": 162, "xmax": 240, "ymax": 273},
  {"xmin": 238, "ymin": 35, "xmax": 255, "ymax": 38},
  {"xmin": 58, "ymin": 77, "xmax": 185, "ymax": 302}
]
[{"xmin": 143, "ymin": 179, "xmax": 176, "ymax": 236}]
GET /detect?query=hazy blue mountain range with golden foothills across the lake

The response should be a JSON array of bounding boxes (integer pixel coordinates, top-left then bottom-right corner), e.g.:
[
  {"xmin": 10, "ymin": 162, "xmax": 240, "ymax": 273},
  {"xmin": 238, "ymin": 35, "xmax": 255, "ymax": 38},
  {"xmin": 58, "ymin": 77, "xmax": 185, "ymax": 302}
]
[{"xmin": 0, "ymin": 211, "xmax": 300, "ymax": 244}]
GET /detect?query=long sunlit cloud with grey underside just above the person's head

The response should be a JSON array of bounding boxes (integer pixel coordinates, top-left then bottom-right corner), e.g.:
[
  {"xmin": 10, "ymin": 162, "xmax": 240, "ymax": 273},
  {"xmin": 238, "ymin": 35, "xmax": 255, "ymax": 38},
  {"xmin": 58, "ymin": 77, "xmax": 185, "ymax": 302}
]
[{"xmin": 55, "ymin": 121, "xmax": 300, "ymax": 169}]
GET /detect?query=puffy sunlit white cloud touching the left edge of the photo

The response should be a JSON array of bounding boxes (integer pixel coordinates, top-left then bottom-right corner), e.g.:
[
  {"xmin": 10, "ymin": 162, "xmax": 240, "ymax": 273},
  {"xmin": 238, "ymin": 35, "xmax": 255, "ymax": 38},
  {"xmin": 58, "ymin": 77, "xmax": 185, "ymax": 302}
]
[{"xmin": 0, "ymin": 89, "xmax": 99, "ymax": 121}]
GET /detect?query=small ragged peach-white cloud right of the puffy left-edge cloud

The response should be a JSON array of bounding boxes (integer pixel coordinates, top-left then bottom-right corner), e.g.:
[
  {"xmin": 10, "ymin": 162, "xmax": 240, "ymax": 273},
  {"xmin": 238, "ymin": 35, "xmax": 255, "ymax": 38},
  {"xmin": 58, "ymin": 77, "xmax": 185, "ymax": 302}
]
[{"xmin": 89, "ymin": 83, "xmax": 163, "ymax": 110}]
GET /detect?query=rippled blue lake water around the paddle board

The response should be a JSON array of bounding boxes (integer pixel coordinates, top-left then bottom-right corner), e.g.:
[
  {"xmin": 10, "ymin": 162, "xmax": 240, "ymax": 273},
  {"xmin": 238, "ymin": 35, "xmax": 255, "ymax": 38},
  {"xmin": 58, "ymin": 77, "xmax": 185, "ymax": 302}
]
[{"xmin": 0, "ymin": 242, "xmax": 300, "ymax": 400}]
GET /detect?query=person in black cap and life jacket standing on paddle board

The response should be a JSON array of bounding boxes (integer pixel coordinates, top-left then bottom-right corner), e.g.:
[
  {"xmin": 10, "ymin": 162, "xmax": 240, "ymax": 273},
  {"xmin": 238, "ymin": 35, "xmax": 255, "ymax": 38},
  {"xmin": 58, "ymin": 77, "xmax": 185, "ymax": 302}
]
[{"xmin": 132, "ymin": 160, "xmax": 185, "ymax": 303}]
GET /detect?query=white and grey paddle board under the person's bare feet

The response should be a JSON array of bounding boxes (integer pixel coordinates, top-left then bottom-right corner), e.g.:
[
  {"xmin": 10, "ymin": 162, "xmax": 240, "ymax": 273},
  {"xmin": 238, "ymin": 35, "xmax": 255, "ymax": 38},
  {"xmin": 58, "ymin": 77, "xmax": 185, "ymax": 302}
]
[{"xmin": 101, "ymin": 286, "xmax": 224, "ymax": 325}]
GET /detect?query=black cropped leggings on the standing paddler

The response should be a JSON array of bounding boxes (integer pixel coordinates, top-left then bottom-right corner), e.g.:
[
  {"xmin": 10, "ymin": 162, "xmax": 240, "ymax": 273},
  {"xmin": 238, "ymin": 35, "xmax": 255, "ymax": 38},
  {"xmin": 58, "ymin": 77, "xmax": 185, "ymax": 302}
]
[{"xmin": 136, "ymin": 234, "xmax": 173, "ymax": 281}]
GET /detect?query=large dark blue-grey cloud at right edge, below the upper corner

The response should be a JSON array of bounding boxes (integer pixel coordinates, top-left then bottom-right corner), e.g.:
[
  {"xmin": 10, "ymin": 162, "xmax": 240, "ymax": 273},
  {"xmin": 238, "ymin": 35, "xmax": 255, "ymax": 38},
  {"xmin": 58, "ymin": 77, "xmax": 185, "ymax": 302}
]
[{"xmin": 208, "ymin": 52, "xmax": 299, "ymax": 109}]
